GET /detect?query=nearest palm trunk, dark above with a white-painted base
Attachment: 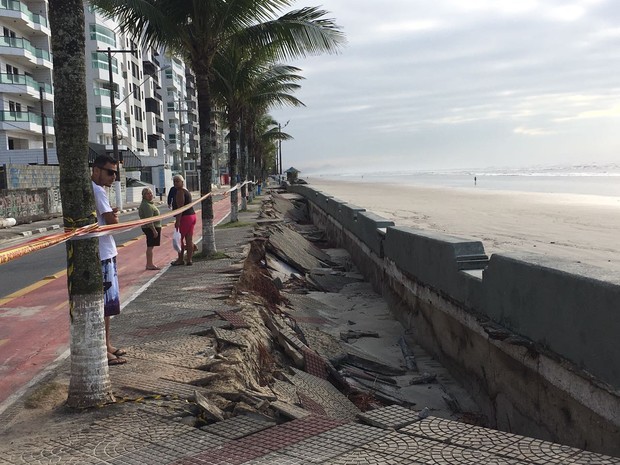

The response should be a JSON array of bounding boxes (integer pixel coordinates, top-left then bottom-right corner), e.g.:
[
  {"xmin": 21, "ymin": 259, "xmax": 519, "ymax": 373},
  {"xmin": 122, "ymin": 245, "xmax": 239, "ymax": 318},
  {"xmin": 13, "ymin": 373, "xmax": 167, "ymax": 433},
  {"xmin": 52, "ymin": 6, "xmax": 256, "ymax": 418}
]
[{"xmin": 49, "ymin": 0, "xmax": 114, "ymax": 407}]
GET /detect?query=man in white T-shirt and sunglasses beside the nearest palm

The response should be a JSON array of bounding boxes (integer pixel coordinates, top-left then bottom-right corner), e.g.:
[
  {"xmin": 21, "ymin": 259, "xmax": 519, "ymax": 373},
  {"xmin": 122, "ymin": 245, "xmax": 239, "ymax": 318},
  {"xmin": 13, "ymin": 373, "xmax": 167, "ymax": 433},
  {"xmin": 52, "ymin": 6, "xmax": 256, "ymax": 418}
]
[{"xmin": 91, "ymin": 155, "xmax": 127, "ymax": 366}]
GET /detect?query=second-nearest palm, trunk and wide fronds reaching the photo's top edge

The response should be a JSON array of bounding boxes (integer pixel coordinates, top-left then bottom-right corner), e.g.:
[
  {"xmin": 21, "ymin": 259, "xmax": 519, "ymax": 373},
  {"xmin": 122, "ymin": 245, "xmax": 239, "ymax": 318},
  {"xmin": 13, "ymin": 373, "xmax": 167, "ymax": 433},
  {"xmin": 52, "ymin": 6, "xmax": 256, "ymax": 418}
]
[{"xmin": 91, "ymin": 0, "xmax": 344, "ymax": 255}]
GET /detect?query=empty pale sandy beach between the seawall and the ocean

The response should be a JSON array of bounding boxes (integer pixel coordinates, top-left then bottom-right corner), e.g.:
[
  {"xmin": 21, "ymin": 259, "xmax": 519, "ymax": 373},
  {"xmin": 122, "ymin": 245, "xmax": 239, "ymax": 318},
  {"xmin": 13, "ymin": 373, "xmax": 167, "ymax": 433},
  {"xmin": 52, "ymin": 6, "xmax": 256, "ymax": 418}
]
[{"xmin": 308, "ymin": 178, "xmax": 620, "ymax": 274}]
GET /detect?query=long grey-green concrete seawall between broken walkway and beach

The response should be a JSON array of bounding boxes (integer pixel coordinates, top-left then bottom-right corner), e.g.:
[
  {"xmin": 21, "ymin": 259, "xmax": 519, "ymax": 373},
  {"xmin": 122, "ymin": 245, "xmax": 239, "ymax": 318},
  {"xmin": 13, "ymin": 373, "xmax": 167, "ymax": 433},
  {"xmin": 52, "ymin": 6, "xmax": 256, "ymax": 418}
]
[{"xmin": 289, "ymin": 185, "xmax": 620, "ymax": 455}]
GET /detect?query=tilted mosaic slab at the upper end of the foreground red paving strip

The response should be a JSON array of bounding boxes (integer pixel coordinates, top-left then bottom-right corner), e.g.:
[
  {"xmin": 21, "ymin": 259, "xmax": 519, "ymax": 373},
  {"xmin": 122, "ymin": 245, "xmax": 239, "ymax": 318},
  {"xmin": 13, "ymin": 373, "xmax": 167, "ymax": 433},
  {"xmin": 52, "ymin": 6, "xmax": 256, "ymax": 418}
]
[{"xmin": 290, "ymin": 368, "xmax": 360, "ymax": 421}]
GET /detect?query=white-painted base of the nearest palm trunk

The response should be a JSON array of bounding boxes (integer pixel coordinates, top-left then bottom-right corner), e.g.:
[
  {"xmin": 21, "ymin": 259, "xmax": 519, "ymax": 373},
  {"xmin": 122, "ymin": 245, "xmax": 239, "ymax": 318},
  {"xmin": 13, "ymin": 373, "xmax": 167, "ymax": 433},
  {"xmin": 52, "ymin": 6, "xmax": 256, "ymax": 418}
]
[{"xmin": 67, "ymin": 293, "xmax": 115, "ymax": 408}]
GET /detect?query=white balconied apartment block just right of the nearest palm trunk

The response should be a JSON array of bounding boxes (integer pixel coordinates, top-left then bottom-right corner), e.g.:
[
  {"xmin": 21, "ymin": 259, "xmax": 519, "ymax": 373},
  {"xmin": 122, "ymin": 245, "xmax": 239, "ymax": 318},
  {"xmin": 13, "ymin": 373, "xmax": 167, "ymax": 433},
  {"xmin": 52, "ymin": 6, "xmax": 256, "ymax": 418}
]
[{"xmin": 85, "ymin": 5, "xmax": 168, "ymax": 159}]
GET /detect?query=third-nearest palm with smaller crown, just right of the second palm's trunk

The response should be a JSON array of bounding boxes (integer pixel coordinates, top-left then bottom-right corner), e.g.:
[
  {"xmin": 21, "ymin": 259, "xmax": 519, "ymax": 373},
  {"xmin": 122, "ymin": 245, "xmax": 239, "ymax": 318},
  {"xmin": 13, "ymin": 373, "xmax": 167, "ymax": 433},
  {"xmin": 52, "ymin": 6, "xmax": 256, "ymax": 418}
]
[{"xmin": 211, "ymin": 42, "xmax": 303, "ymax": 222}]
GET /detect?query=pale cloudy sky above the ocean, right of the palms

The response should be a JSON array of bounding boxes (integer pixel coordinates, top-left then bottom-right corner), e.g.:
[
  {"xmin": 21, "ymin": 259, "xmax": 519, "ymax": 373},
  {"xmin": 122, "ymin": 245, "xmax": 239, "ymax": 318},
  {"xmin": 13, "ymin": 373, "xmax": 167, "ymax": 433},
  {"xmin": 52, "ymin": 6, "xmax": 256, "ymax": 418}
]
[{"xmin": 271, "ymin": 0, "xmax": 620, "ymax": 177}]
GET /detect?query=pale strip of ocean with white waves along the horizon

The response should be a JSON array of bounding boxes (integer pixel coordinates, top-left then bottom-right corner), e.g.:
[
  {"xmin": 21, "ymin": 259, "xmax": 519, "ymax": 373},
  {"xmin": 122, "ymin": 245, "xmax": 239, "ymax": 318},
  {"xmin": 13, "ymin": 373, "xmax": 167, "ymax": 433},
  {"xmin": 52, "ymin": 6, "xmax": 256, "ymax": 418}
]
[{"xmin": 305, "ymin": 164, "xmax": 620, "ymax": 197}]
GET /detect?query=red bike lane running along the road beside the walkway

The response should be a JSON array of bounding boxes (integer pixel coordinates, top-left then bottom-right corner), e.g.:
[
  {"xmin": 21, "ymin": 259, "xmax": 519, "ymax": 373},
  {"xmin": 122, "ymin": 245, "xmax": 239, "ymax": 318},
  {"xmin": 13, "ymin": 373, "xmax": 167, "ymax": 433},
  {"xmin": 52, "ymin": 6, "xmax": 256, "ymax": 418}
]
[{"xmin": 0, "ymin": 197, "xmax": 230, "ymax": 412}]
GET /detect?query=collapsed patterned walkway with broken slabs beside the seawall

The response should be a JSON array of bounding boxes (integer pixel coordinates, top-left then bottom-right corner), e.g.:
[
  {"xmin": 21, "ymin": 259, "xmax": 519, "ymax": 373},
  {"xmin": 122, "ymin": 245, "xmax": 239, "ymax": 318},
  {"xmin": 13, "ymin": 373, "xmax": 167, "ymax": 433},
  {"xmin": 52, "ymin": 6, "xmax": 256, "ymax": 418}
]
[{"xmin": 0, "ymin": 190, "xmax": 620, "ymax": 465}]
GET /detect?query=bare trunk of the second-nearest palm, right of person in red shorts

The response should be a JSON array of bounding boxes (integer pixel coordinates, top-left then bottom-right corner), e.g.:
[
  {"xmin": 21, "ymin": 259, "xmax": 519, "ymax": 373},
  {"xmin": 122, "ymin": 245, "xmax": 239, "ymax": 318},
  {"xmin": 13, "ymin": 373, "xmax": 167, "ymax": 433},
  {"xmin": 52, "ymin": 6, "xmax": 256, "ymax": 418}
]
[{"xmin": 199, "ymin": 70, "xmax": 217, "ymax": 256}]
